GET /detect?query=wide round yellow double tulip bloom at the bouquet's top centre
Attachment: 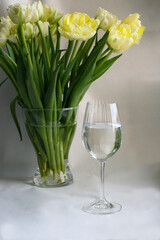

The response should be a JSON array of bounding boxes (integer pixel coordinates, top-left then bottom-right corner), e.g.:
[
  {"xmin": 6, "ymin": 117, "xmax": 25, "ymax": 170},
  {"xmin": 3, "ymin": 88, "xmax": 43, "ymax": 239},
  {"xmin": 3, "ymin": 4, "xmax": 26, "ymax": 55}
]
[{"xmin": 58, "ymin": 12, "xmax": 100, "ymax": 41}]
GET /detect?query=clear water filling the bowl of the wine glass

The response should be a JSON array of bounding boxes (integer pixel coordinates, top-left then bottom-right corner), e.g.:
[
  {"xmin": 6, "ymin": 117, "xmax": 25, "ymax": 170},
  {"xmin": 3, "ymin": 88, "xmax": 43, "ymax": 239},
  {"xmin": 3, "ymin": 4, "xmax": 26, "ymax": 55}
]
[{"xmin": 82, "ymin": 122, "xmax": 121, "ymax": 161}]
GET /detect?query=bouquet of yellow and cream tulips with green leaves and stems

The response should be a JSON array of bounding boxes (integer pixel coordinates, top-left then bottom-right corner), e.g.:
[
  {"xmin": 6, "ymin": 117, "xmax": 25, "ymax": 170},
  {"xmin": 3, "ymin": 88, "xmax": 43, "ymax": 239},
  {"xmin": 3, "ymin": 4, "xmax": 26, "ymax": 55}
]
[{"xmin": 0, "ymin": 1, "xmax": 144, "ymax": 185}]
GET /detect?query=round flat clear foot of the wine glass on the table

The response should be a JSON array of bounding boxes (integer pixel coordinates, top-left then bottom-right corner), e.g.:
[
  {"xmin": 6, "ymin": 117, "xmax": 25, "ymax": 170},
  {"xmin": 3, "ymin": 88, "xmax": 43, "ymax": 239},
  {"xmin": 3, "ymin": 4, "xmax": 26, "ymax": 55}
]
[{"xmin": 82, "ymin": 200, "xmax": 122, "ymax": 215}]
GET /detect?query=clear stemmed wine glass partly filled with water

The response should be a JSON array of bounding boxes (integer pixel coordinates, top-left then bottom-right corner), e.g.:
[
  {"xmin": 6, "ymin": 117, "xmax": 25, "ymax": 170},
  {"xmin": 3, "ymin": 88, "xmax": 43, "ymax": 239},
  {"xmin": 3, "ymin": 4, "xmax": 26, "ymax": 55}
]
[{"xmin": 82, "ymin": 100, "xmax": 122, "ymax": 214}]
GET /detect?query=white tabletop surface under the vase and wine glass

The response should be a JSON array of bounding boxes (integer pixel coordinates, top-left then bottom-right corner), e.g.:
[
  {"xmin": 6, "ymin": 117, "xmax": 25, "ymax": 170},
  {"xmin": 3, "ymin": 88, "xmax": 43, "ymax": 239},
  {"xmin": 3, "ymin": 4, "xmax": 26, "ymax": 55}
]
[{"xmin": 0, "ymin": 163, "xmax": 160, "ymax": 240}]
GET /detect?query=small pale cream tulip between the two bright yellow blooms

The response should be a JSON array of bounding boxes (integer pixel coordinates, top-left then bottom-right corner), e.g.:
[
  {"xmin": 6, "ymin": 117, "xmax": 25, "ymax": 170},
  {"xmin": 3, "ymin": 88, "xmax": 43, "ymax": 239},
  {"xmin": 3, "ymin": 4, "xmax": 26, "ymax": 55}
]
[{"xmin": 96, "ymin": 7, "xmax": 118, "ymax": 31}]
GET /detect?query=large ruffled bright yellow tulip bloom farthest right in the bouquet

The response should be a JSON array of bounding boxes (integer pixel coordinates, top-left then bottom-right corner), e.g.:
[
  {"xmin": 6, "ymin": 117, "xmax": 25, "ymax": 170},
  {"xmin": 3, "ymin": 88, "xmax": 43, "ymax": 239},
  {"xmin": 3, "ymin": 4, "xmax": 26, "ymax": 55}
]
[{"xmin": 107, "ymin": 13, "xmax": 145, "ymax": 52}]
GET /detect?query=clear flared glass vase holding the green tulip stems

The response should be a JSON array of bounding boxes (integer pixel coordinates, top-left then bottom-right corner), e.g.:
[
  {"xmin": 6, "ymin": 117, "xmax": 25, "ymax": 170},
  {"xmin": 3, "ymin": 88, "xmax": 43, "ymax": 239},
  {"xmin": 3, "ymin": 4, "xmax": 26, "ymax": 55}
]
[{"xmin": 23, "ymin": 107, "xmax": 78, "ymax": 187}]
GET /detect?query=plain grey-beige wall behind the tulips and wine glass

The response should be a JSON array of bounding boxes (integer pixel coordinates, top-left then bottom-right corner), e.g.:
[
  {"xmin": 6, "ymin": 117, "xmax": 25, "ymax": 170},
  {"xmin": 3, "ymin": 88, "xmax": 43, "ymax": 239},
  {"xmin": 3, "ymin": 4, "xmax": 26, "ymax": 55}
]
[{"xmin": 0, "ymin": 0, "xmax": 160, "ymax": 178}]
